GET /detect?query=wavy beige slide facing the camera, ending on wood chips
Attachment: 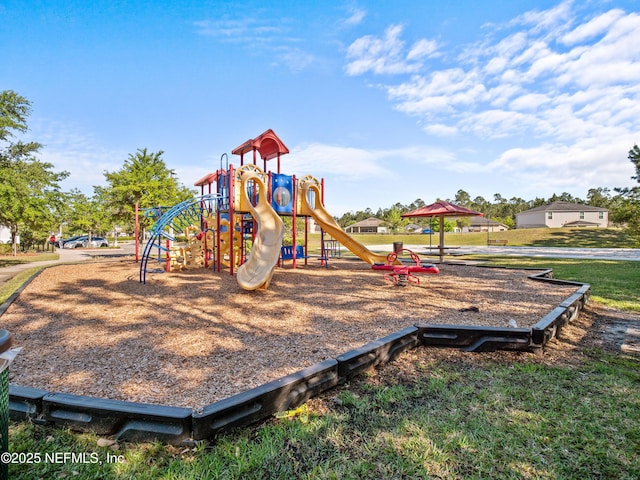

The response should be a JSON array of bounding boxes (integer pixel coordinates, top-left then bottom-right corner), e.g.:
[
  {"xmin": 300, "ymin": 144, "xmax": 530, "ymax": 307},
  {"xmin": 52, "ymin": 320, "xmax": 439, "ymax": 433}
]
[{"xmin": 236, "ymin": 165, "xmax": 284, "ymax": 290}]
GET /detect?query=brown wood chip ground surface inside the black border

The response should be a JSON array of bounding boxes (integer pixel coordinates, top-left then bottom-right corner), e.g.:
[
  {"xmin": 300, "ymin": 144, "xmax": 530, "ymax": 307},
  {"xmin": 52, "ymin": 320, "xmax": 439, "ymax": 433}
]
[{"xmin": 1, "ymin": 259, "xmax": 577, "ymax": 409}]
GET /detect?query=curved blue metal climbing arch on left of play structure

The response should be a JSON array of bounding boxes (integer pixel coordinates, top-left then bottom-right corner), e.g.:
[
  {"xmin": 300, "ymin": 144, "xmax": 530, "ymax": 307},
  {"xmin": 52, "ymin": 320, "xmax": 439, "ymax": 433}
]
[{"xmin": 140, "ymin": 193, "xmax": 220, "ymax": 283}]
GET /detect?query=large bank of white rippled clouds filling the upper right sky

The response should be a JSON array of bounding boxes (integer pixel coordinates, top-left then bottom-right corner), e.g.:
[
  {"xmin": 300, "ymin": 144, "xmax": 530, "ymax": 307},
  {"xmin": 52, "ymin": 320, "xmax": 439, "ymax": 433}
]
[{"xmin": 347, "ymin": 1, "xmax": 640, "ymax": 197}]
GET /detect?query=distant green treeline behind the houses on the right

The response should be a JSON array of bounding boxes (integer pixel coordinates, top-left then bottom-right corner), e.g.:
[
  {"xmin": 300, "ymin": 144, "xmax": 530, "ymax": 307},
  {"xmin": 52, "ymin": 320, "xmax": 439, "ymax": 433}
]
[{"xmin": 338, "ymin": 188, "xmax": 627, "ymax": 231}]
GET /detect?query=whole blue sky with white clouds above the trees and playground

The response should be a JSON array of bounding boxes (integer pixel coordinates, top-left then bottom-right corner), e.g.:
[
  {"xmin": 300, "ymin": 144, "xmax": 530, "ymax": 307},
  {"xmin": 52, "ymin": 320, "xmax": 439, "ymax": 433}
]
[{"xmin": 0, "ymin": 0, "xmax": 640, "ymax": 215}]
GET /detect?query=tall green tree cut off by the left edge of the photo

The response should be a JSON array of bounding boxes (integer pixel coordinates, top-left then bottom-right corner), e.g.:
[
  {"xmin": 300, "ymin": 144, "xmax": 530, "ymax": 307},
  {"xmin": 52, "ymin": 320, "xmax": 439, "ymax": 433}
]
[{"xmin": 0, "ymin": 90, "xmax": 69, "ymax": 255}]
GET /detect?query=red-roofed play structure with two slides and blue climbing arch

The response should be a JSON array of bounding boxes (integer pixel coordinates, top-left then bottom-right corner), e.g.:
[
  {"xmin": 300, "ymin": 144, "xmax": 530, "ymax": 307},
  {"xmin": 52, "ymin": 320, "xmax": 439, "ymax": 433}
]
[{"xmin": 140, "ymin": 130, "xmax": 404, "ymax": 290}]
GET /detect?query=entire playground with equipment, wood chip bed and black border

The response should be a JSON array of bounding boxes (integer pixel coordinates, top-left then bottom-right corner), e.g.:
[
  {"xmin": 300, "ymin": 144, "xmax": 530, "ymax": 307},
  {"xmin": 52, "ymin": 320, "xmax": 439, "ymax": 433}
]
[{"xmin": 2, "ymin": 130, "xmax": 590, "ymax": 443}]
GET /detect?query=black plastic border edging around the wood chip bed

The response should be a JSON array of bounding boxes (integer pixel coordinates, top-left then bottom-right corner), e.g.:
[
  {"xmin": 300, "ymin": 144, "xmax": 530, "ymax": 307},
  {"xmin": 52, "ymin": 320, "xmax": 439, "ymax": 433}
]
[{"xmin": 9, "ymin": 262, "xmax": 590, "ymax": 444}]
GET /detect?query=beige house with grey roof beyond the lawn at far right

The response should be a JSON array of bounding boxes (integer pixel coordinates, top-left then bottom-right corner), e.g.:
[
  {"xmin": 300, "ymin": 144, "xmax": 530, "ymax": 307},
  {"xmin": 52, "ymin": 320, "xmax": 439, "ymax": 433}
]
[{"xmin": 516, "ymin": 202, "xmax": 609, "ymax": 228}]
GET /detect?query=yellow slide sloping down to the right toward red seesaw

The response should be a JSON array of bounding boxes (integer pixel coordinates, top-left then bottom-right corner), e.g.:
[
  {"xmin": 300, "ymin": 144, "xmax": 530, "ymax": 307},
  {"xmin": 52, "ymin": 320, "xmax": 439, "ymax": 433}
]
[{"xmin": 298, "ymin": 175, "xmax": 387, "ymax": 265}]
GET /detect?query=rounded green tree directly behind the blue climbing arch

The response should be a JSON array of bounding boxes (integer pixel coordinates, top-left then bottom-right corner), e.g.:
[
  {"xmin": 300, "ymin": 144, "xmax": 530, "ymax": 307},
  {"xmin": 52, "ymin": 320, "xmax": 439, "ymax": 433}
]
[{"xmin": 97, "ymin": 148, "xmax": 195, "ymax": 236}]
